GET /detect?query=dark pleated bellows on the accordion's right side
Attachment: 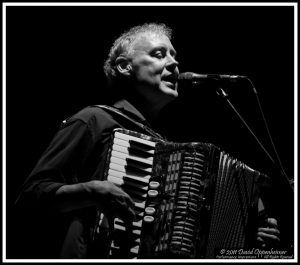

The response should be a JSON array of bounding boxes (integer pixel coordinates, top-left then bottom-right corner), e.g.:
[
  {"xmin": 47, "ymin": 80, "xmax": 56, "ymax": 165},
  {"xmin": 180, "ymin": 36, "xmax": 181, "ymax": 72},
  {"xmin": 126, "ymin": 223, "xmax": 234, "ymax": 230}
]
[{"xmin": 205, "ymin": 152, "xmax": 257, "ymax": 258}]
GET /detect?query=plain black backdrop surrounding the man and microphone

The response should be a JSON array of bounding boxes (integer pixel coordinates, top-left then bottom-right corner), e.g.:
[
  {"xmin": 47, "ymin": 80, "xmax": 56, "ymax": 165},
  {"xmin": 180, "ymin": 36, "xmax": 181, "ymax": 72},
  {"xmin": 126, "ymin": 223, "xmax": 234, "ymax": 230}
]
[{"xmin": 6, "ymin": 3, "xmax": 294, "ymax": 256}]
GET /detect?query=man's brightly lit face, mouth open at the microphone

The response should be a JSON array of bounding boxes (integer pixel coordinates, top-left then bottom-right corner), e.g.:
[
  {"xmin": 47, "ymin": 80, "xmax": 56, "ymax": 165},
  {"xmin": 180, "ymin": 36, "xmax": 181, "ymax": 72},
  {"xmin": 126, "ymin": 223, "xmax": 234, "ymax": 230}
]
[{"xmin": 130, "ymin": 33, "xmax": 179, "ymax": 103}]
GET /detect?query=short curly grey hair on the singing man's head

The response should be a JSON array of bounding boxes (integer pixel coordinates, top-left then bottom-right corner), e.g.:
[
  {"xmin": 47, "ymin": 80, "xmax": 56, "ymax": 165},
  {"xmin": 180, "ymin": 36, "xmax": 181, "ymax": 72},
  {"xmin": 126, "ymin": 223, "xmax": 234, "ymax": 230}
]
[{"xmin": 103, "ymin": 23, "xmax": 172, "ymax": 83}]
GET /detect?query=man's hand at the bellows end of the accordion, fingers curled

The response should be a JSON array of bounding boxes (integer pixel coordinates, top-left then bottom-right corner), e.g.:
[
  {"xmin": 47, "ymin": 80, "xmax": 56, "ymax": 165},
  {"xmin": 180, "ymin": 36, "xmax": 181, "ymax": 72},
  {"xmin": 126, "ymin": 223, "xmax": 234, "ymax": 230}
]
[{"xmin": 256, "ymin": 218, "xmax": 280, "ymax": 248}]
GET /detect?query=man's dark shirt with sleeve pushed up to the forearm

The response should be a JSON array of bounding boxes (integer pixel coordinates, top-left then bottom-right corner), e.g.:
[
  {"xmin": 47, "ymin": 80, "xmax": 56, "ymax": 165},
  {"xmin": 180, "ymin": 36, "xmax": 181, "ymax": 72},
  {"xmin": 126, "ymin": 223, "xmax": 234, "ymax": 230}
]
[{"xmin": 17, "ymin": 100, "xmax": 159, "ymax": 258}]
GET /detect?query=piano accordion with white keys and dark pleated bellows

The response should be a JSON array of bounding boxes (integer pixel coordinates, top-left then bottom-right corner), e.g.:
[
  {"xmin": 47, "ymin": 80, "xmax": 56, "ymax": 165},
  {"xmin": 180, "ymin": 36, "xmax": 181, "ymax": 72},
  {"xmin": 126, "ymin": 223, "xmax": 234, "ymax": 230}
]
[{"xmin": 93, "ymin": 129, "xmax": 265, "ymax": 258}]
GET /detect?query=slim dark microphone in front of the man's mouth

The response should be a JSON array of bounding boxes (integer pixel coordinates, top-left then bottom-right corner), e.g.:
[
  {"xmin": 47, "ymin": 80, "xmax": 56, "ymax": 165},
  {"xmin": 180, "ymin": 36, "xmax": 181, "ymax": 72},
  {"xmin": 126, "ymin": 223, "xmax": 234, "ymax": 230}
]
[{"xmin": 178, "ymin": 72, "xmax": 247, "ymax": 84}]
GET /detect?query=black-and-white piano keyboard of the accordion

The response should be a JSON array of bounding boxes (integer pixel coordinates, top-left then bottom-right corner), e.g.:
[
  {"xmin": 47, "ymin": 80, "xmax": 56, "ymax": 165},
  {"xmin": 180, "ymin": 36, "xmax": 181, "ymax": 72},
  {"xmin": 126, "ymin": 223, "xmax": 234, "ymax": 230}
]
[{"xmin": 107, "ymin": 132, "xmax": 160, "ymax": 257}]
